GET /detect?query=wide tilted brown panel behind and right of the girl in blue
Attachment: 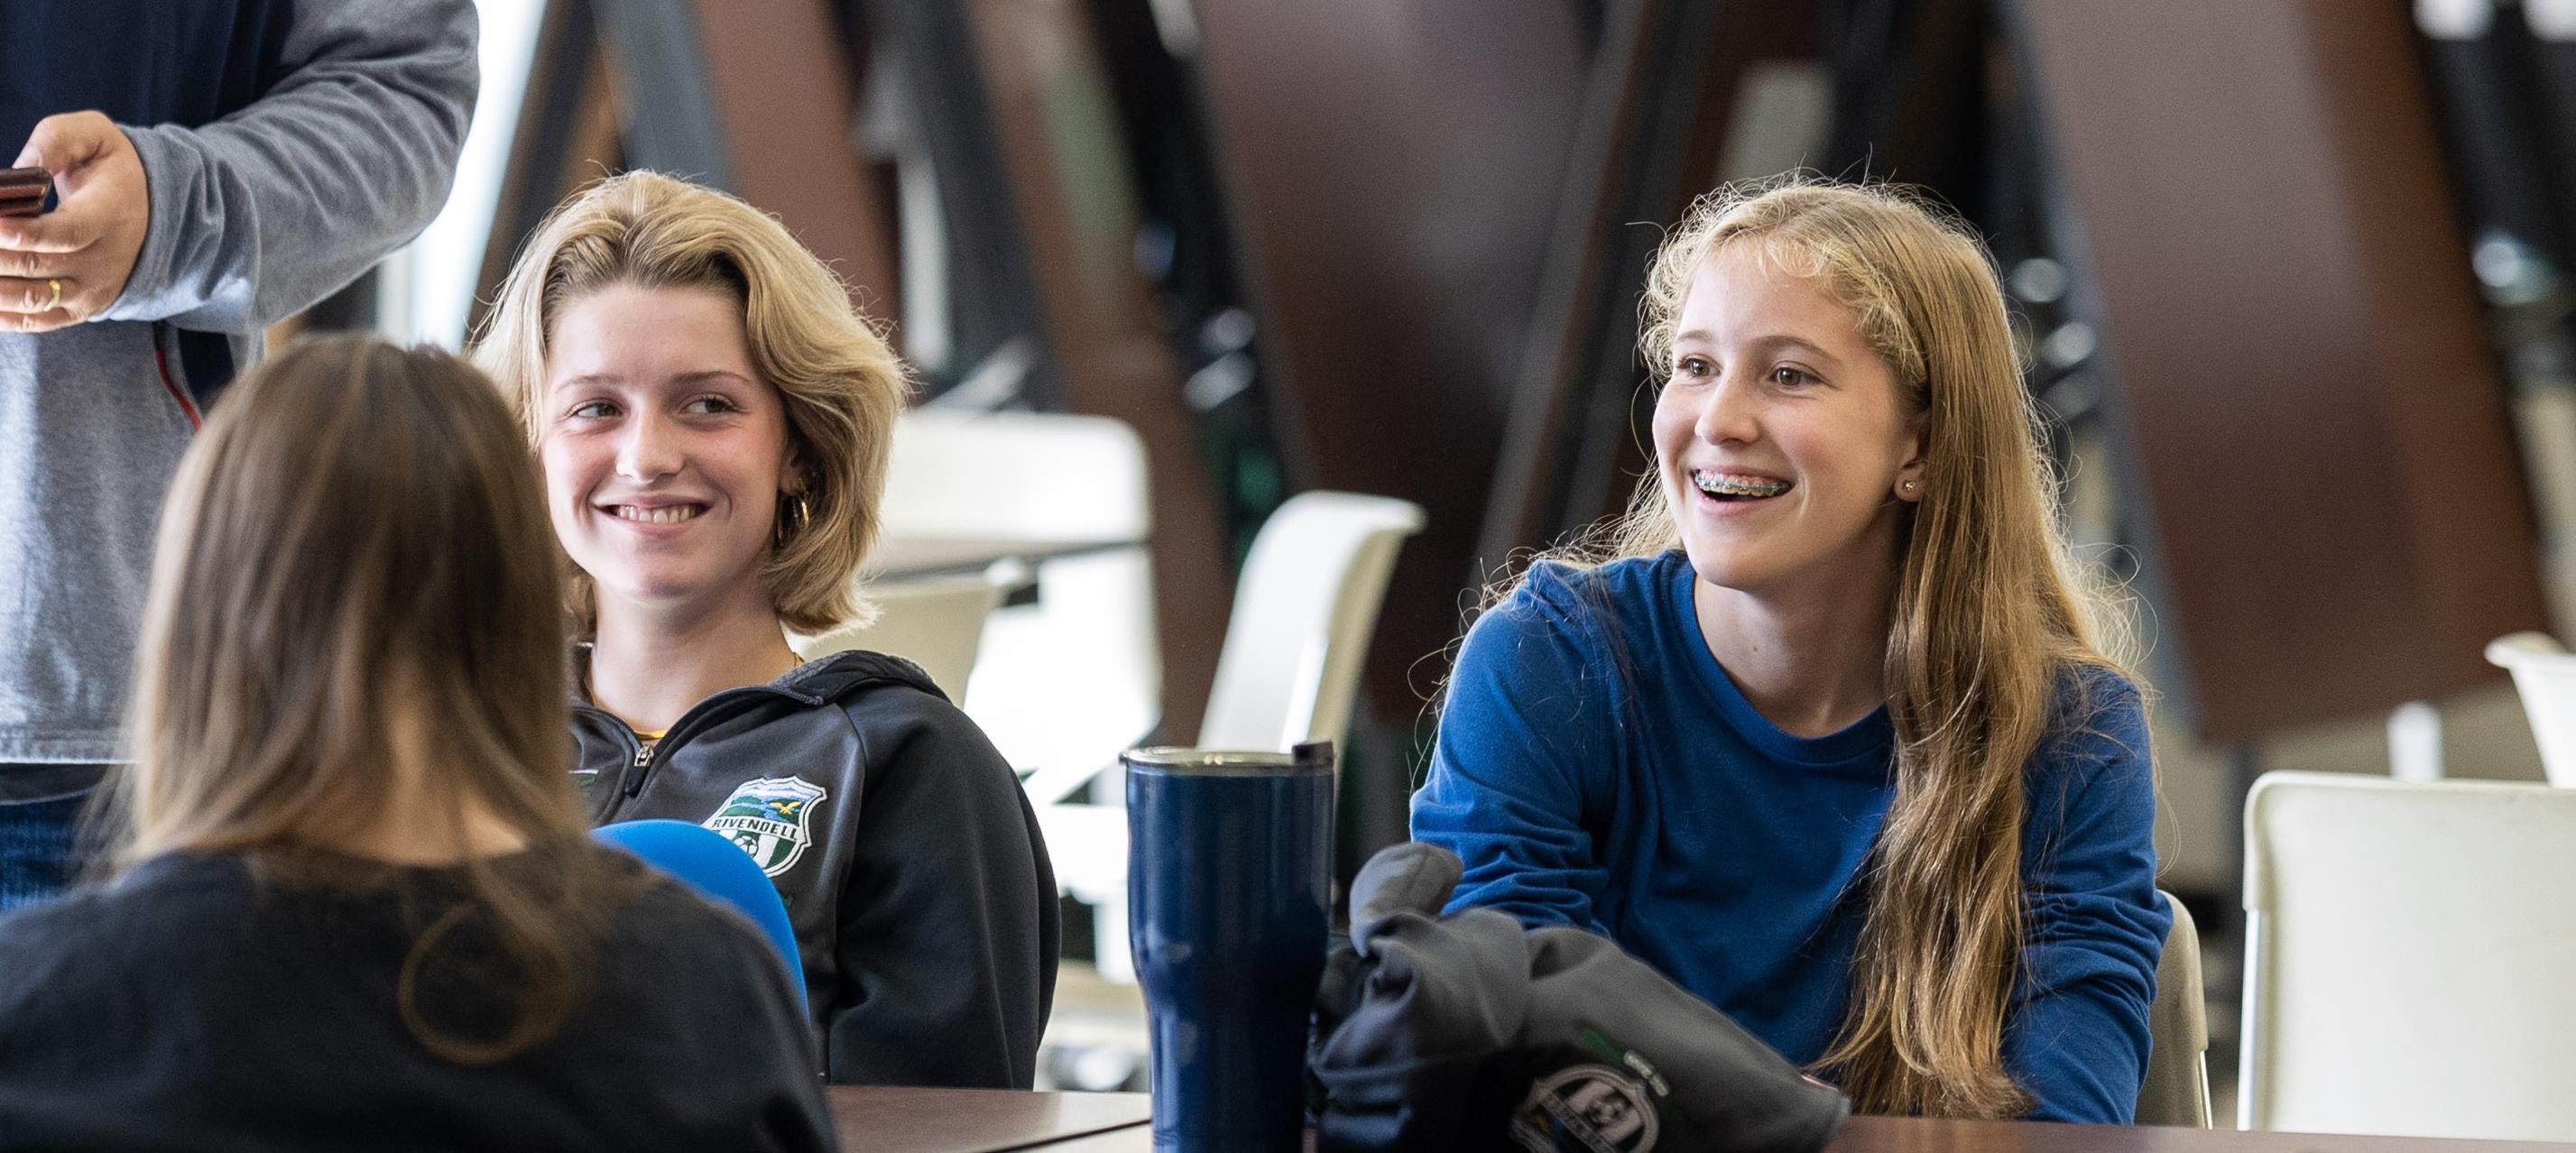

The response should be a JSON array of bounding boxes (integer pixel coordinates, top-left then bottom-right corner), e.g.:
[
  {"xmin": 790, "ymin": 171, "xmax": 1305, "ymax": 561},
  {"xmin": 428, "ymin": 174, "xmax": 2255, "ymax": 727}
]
[{"xmin": 2012, "ymin": 0, "xmax": 2543, "ymax": 739}]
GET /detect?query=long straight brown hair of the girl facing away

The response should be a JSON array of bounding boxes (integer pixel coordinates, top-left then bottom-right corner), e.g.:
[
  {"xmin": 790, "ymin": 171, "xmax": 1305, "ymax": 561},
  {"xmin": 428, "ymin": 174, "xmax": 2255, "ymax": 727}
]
[{"xmin": 106, "ymin": 337, "xmax": 621, "ymax": 1063}]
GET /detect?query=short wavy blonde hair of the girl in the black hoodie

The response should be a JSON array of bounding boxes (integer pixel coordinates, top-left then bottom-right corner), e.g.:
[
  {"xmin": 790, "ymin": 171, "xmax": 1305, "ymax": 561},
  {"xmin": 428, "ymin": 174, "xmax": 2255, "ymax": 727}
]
[{"xmin": 474, "ymin": 172, "xmax": 909, "ymax": 636}]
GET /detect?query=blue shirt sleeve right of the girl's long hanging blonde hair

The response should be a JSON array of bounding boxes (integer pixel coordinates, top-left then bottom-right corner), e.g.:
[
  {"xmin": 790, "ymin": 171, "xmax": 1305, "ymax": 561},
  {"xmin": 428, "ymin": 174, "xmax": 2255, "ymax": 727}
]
[{"xmin": 2004, "ymin": 672, "xmax": 2174, "ymax": 1125}]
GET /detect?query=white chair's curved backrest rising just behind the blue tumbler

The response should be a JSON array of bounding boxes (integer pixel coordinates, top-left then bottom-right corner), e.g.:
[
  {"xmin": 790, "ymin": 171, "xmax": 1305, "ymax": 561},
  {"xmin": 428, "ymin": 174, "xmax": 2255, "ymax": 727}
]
[{"xmin": 1198, "ymin": 492, "xmax": 1422, "ymax": 752}]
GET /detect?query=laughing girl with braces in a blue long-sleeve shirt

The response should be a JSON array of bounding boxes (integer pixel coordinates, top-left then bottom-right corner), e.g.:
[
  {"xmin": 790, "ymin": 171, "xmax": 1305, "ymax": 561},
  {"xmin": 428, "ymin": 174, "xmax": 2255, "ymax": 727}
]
[{"xmin": 1414, "ymin": 183, "xmax": 2172, "ymax": 1122}]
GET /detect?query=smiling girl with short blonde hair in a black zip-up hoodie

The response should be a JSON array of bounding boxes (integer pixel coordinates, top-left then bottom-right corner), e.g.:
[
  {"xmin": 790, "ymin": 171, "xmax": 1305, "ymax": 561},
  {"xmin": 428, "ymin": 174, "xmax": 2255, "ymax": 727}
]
[{"xmin": 476, "ymin": 172, "xmax": 1058, "ymax": 1089}]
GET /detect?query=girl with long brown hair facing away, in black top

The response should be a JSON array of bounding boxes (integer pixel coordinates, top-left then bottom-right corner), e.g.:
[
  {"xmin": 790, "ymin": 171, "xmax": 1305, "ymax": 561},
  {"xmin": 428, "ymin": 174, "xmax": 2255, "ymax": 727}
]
[{"xmin": 0, "ymin": 337, "xmax": 832, "ymax": 1150}]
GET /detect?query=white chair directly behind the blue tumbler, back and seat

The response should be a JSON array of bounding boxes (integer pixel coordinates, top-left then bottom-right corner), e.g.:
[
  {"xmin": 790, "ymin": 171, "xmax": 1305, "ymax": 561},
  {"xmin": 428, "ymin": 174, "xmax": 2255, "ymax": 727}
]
[{"xmin": 1028, "ymin": 492, "xmax": 1422, "ymax": 983}]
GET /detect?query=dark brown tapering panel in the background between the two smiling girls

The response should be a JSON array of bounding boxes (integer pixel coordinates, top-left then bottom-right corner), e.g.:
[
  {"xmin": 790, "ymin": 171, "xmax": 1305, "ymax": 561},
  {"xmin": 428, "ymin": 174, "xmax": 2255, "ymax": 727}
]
[{"xmin": 1196, "ymin": 0, "xmax": 1590, "ymax": 718}]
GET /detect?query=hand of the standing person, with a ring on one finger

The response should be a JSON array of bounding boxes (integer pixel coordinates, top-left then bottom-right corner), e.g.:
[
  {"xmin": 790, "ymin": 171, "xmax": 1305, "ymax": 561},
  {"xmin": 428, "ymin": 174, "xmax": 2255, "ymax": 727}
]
[{"xmin": 0, "ymin": 111, "xmax": 152, "ymax": 332}]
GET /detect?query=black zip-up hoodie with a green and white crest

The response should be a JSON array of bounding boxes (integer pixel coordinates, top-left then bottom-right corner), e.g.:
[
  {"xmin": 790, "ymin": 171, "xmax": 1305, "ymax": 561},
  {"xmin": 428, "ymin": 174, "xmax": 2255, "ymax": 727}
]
[{"xmin": 572, "ymin": 651, "xmax": 1061, "ymax": 1089}]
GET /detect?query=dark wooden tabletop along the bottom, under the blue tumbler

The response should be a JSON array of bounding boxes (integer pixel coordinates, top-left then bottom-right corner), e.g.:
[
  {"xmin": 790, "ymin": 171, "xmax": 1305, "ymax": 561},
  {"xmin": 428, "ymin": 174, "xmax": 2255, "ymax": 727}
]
[{"xmin": 832, "ymin": 1089, "xmax": 2576, "ymax": 1153}]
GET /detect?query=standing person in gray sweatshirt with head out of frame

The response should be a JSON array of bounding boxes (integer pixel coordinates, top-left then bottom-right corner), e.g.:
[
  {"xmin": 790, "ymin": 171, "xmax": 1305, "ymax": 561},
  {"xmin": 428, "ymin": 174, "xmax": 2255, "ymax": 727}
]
[{"xmin": 0, "ymin": 0, "xmax": 476, "ymax": 909}]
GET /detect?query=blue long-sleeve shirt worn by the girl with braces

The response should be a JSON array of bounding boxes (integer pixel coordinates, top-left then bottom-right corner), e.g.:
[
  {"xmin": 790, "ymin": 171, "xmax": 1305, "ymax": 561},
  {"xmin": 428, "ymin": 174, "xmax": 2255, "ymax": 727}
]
[{"xmin": 1414, "ymin": 550, "xmax": 2172, "ymax": 1122}]
